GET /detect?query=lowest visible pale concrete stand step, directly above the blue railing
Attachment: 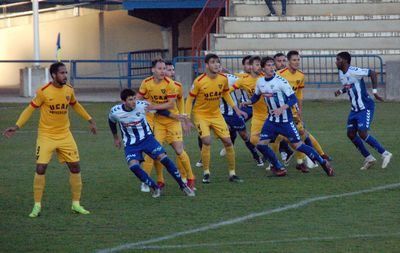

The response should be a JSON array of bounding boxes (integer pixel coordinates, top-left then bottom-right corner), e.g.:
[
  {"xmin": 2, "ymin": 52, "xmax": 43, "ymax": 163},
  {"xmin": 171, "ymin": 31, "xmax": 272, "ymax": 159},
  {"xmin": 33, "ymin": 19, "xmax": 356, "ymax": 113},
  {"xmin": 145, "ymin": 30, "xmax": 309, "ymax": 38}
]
[{"xmin": 211, "ymin": 32, "xmax": 400, "ymax": 50}]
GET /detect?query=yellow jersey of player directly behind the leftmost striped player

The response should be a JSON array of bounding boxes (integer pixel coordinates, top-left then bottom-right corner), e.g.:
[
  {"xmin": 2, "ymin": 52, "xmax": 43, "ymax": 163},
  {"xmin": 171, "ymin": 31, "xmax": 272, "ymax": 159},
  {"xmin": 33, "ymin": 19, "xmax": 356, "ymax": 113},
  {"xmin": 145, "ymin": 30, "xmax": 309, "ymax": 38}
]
[{"xmin": 139, "ymin": 76, "xmax": 179, "ymax": 121}]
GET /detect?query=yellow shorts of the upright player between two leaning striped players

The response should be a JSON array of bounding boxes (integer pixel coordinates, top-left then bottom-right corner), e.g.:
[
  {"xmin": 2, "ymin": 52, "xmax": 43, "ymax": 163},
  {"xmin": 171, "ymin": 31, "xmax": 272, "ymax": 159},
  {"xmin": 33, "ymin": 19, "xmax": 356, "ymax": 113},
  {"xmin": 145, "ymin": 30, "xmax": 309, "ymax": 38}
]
[{"xmin": 193, "ymin": 115, "xmax": 230, "ymax": 138}]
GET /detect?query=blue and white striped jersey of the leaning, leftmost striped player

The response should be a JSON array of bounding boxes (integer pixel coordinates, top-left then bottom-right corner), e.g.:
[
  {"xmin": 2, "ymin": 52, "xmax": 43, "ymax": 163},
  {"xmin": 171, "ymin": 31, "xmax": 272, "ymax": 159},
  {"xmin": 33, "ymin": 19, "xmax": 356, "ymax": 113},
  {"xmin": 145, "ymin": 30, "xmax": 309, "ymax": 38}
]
[{"xmin": 108, "ymin": 100, "xmax": 153, "ymax": 146}]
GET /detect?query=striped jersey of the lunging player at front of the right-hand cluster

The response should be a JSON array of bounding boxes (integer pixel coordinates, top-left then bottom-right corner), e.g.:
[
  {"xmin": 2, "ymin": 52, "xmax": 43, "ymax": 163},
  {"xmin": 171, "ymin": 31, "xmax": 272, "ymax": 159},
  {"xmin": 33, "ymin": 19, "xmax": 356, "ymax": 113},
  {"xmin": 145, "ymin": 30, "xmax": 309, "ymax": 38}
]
[{"xmin": 255, "ymin": 74, "xmax": 294, "ymax": 123}]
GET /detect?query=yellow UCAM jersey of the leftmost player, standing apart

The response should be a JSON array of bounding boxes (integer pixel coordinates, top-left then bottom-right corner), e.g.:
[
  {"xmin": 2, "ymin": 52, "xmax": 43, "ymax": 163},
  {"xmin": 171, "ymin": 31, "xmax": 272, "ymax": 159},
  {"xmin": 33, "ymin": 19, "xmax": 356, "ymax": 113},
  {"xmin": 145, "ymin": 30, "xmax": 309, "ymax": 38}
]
[{"xmin": 30, "ymin": 82, "xmax": 91, "ymax": 139}]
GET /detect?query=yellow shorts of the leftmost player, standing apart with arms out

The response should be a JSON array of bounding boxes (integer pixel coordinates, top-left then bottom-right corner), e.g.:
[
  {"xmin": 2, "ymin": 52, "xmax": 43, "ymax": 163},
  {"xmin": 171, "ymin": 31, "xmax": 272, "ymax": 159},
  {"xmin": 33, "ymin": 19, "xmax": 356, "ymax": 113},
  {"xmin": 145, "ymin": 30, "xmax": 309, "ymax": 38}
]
[{"xmin": 36, "ymin": 133, "xmax": 79, "ymax": 164}]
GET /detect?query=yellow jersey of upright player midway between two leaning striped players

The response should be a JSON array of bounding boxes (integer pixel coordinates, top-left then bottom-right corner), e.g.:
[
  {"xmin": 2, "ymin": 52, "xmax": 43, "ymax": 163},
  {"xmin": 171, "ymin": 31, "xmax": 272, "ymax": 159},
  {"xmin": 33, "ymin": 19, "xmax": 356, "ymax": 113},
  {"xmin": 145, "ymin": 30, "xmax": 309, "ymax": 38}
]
[{"xmin": 189, "ymin": 73, "xmax": 229, "ymax": 117}]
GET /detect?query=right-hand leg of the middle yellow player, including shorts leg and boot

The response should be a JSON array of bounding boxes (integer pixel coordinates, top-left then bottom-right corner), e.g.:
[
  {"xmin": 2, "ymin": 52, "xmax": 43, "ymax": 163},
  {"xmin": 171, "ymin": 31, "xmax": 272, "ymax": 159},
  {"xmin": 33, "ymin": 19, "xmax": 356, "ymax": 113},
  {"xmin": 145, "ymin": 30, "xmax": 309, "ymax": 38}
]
[{"xmin": 214, "ymin": 117, "xmax": 243, "ymax": 183}]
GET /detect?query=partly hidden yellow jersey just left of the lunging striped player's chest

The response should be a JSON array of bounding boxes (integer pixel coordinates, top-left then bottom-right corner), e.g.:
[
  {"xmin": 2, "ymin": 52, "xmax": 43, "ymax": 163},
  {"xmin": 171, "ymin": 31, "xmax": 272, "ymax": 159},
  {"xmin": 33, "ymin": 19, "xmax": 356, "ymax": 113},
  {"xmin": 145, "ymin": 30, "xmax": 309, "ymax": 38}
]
[{"xmin": 233, "ymin": 74, "xmax": 268, "ymax": 120}]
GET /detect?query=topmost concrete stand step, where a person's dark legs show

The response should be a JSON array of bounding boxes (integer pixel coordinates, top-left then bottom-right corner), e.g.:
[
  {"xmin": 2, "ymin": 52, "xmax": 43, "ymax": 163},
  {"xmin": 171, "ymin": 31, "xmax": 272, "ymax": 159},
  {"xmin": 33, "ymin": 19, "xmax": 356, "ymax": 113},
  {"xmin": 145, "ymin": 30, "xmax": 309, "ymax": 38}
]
[{"xmin": 231, "ymin": 0, "xmax": 400, "ymax": 16}]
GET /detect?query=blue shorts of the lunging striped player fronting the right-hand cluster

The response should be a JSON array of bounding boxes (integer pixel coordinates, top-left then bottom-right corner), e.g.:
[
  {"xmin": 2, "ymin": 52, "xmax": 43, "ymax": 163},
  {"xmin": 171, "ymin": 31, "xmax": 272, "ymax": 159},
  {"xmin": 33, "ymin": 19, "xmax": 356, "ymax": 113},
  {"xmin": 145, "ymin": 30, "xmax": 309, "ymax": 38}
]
[{"xmin": 260, "ymin": 120, "xmax": 301, "ymax": 143}]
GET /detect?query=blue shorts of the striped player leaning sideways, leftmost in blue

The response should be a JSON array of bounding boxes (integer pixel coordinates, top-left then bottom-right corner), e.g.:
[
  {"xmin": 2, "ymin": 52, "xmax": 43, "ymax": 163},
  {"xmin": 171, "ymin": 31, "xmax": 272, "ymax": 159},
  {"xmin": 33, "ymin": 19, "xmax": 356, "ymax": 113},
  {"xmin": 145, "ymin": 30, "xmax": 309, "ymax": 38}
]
[{"xmin": 125, "ymin": 135, "xmax": 165, "ymax": 164}]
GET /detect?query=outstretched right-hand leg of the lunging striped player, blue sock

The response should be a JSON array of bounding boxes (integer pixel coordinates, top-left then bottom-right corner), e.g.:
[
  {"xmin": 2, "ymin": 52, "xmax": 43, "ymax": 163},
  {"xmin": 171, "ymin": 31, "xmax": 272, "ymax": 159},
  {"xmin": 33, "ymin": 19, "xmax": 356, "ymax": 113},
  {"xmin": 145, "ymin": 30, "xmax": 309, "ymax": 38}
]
[{"xmin": 278, "ymin": 122, "xmax": 334, "ymax": 176}]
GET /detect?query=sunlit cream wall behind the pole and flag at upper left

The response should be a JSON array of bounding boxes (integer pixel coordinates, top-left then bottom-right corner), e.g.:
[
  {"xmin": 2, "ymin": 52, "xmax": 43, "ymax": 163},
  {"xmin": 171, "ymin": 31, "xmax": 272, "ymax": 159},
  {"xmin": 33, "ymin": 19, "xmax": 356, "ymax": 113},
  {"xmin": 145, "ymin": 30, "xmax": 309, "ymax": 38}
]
[{"xmin": 0, "ymin": 8, "xmax": 195, "ymax": 88}]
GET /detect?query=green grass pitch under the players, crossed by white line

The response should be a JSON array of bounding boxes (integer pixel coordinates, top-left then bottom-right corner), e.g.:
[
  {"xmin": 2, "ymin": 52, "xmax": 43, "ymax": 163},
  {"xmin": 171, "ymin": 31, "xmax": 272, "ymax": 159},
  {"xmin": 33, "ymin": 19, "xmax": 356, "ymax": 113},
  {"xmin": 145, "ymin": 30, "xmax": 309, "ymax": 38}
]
[{"xmin": 0, "ymin": 101, "xmax": 400, "ymax": 252}]
